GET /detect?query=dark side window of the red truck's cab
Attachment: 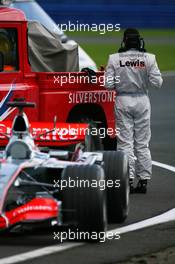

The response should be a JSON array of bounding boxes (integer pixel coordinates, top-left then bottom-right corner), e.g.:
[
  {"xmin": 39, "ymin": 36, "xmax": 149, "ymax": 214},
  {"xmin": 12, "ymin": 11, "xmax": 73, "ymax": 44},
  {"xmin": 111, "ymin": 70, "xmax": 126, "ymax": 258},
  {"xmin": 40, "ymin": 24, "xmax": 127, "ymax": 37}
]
[{"xmin": 0, "ymin": 28, "xmax": 19, "ymax": 72}]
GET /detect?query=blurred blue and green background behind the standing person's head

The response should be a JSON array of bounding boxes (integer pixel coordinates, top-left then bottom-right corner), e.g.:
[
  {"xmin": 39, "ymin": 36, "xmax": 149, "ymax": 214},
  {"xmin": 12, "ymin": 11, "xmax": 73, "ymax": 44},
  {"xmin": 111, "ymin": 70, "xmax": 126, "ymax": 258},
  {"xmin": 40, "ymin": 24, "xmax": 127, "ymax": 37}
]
[{"xmin": 37, "ymin": 0, "xmax": 175, "ymax": 71}]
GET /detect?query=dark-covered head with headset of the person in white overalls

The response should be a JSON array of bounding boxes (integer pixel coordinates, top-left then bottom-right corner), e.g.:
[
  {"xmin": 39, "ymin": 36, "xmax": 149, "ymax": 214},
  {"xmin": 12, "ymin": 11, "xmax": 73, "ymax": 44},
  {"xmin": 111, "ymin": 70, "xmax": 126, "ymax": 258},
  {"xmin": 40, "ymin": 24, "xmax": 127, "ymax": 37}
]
[{"xmin": 118, "ymin": 28, "xmax": 146, "ymax": 52}]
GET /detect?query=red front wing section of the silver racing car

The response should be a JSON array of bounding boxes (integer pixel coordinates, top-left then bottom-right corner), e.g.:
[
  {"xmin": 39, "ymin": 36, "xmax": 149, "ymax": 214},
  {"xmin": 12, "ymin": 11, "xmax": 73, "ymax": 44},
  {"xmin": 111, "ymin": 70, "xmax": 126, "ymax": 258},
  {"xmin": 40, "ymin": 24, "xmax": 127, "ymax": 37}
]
[{"xmin": 0, "ymin": 198, "xmax": 59, "ymax": 229}]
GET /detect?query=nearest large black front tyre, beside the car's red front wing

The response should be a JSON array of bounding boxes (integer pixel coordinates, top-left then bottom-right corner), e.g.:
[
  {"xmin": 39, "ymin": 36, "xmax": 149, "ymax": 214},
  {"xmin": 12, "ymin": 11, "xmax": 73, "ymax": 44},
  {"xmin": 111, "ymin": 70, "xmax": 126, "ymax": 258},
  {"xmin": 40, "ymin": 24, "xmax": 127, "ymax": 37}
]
[{"xmin": 62, "ymin": 164, "xmax": 106, "ymax": 242}]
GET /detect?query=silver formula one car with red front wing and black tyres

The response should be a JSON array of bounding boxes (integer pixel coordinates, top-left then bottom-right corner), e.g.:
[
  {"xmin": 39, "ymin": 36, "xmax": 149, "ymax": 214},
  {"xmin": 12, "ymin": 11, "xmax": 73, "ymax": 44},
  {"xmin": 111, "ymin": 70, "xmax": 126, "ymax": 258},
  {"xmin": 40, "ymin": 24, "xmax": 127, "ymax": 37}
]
[{"xmin": 0, "ymin": 102, "xmax": 129, "ymax": 241}]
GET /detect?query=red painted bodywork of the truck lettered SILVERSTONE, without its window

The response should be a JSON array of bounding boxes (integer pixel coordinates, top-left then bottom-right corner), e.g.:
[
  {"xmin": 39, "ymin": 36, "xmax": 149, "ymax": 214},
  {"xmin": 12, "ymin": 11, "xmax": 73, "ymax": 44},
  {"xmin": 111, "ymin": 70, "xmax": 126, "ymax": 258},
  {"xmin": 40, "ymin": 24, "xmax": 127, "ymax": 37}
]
[{"xmin": 0, "ymin": 8, "xmax": 115, "ymax": 145}]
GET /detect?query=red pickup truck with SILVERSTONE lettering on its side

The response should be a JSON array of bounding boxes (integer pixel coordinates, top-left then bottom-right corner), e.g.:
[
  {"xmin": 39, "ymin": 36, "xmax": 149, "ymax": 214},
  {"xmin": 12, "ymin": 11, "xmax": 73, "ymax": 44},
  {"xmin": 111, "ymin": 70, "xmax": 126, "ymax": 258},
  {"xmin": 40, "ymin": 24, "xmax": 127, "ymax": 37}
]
[{"xmin": 0, "ymin": 7, "xmax": 116, "ymax": 148}]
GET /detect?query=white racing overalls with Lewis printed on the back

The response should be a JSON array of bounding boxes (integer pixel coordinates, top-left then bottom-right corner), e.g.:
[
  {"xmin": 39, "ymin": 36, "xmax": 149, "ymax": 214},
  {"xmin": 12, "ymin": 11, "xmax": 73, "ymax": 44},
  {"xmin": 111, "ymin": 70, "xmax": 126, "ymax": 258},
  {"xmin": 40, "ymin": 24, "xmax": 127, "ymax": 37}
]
[{"xmin": 105, "ymin": 49, "xmax": 163, "ymax": 179}]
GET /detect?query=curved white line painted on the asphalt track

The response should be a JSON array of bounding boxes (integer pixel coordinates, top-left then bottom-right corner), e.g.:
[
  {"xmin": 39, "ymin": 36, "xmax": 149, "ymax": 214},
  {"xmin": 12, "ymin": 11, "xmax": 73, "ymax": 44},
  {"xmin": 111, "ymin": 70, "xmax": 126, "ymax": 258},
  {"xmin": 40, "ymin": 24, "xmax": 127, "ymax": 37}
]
[{"xmin": 0, "ymin": 161, "xmax": 175, "ymax": 264}]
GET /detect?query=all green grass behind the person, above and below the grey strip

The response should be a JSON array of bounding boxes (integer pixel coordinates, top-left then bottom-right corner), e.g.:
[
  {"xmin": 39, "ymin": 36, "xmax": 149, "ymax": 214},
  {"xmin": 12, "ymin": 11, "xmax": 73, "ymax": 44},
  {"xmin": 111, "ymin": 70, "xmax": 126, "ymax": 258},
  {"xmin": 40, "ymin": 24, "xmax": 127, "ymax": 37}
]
[{"xmin": 66, "ymin": 29, "xmax": 175, "ymax": 71}]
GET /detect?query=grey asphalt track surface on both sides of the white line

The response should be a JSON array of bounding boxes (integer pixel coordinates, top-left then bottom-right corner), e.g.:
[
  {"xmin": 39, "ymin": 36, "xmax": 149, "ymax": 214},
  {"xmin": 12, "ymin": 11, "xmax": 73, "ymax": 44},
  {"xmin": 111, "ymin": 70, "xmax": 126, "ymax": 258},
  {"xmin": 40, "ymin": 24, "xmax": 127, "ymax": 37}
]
[{"xmin": 0, "ymin": 76, "xmax": 175, "ymax": 264}]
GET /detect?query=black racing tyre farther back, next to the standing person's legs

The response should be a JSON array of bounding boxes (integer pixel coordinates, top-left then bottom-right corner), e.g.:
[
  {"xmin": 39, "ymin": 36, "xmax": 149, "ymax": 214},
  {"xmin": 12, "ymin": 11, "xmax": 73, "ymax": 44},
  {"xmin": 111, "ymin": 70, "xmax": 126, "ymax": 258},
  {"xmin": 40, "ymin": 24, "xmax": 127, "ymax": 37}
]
[{"xmin": 103, "ymin": 151, "xmax": 129, "ymax": 223}]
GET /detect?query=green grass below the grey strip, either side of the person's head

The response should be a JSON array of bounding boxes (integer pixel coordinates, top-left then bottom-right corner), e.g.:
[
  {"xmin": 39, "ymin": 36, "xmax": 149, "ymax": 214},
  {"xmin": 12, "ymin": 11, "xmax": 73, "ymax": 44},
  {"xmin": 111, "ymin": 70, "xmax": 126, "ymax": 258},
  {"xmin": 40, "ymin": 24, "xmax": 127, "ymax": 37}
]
[{"xmin": 81, "ymin": 43, "xmax": 175, "ymax": 71}]
